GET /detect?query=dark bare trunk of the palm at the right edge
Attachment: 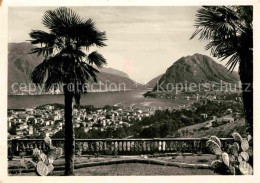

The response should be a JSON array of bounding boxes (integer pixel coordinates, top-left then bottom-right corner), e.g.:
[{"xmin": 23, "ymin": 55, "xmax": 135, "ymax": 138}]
[{"xmin": 239, "ymin": 53, "xmax": 253, "ymax": 136}]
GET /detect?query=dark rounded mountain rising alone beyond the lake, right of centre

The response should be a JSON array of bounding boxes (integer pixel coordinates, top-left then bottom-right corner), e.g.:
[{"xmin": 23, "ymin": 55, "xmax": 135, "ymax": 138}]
[{"xmin": 154, "ymin": 53, "xmax": 239, "ymax": 89}]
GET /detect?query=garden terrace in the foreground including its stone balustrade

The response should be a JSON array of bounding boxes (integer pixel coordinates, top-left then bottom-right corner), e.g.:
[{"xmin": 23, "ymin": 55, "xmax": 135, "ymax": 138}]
[{"xmin": 8, "ymin": 138, "xmax": 233, "ymax": 175}]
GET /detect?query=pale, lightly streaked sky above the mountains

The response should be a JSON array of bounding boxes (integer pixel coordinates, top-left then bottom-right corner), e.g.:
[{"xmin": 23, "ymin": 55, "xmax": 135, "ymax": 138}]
[{"xmin": 8, "ymin": 6, "xmax": 237, "ymax": 83}]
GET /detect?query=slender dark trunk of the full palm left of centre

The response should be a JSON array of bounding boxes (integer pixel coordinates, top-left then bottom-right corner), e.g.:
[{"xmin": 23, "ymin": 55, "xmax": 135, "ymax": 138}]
[{"xmin": 63, "ymin": 85, "xmax": 75, "ymax": 175}]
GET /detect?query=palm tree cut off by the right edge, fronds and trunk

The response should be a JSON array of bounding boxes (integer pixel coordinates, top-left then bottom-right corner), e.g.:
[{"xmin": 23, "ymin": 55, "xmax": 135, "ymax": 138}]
[{"xmin": 191, "ymin": 6, "xmax": 253, "ymax": 134}]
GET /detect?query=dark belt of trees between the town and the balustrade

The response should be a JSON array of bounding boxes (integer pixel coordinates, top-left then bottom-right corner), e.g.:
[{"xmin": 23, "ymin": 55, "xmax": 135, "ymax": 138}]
[{"xmin": 52, "ymin": 100, "xmax": 243, "ymax": 139}]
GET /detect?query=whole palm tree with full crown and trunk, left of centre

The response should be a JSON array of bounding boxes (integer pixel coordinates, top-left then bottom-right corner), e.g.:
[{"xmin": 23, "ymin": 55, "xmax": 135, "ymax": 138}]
[{"xmin": 29, "ymin": 7, "xmax": 106, "ymax": 175}]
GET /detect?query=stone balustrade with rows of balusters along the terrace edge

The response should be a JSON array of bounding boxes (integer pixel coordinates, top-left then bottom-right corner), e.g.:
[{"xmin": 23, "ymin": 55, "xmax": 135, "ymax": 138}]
[{"xmin": 8, "ymin": 138, "xmax": 233, "ymax": 156}]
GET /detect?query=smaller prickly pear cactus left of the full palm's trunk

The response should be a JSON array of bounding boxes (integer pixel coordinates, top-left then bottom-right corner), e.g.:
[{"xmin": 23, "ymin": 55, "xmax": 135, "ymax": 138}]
[{"xmin": 21, "ymin": 137, "xmax": 62, "ymax": 176}]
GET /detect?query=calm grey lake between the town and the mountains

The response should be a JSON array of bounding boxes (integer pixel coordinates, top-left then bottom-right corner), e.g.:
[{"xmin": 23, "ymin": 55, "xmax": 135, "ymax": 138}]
[{"xmin": 8, "ymin": 90, "xmax": 192, "ymax": 109}]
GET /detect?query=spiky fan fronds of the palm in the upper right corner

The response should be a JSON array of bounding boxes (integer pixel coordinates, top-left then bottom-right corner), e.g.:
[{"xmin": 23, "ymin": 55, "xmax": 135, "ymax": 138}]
[{"xmin": 191, "ymin": 6, "xmax": 253, "ymax": 71}]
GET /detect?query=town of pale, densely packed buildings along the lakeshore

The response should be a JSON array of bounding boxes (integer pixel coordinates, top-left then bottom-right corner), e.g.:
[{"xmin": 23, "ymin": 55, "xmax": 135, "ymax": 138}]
[{"xmin": 8, "ymin": 93, "xmax": 242, "ymax": 139}]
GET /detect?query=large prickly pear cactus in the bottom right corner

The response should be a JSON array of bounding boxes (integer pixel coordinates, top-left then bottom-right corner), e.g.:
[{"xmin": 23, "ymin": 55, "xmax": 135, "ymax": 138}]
[{"xmin": 207, "ymin": 132, "xmax": 253, "ymax": 175}]
